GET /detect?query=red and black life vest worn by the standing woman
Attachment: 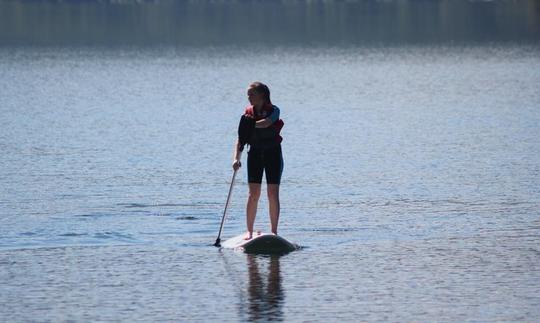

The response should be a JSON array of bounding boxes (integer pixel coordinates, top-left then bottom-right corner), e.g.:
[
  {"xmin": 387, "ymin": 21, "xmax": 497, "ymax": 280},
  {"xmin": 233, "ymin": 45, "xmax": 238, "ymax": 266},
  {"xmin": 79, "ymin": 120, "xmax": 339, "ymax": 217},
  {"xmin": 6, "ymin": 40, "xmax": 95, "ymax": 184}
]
[{"xmin": 244, "ymin": 104, "xmax": 285, "ymax": 147}]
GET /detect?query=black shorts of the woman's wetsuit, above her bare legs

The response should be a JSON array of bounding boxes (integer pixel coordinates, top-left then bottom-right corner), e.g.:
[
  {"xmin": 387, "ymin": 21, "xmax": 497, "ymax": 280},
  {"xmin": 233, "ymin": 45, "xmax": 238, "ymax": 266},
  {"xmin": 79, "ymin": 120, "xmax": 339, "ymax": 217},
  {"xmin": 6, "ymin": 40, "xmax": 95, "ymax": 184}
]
[{"xmin": 248, "ymin": 145, "xmax": 283, "ymax": 184}]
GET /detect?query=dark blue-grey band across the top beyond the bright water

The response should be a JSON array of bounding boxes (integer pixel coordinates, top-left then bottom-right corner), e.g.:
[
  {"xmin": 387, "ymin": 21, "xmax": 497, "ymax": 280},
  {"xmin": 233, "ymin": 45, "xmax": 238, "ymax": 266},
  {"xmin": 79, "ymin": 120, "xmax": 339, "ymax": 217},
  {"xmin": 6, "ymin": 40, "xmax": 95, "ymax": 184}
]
[{"xmin": 0, "ymin": 0, "xmax": 540, "ymax": 46}]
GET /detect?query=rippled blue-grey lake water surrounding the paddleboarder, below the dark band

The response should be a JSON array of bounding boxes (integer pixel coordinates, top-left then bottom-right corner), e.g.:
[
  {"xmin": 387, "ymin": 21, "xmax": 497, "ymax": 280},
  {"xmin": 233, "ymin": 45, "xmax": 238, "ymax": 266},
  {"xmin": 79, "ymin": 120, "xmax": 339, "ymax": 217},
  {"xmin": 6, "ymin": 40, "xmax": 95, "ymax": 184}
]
[{"xmin": 0, "ymin": 1, "xmax": 540, "ymax": 322}]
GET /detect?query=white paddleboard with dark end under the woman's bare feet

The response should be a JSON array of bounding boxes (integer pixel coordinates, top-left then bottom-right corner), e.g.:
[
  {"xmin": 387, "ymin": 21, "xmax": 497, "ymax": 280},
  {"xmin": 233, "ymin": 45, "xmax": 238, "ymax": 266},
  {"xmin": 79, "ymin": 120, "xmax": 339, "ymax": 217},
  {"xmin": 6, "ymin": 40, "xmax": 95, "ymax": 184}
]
[{"xmin": 222, "ymin": 233, "xmax": 298, "ymax": 254}]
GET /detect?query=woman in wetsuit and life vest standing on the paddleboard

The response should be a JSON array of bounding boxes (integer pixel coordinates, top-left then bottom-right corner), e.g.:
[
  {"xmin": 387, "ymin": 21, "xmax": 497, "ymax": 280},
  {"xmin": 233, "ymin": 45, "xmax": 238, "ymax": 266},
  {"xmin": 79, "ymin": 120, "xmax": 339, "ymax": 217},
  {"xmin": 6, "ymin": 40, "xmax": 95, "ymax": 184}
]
[{"xmin": 233, "ymin": 82, "xmax": 283, "ymax": 240}]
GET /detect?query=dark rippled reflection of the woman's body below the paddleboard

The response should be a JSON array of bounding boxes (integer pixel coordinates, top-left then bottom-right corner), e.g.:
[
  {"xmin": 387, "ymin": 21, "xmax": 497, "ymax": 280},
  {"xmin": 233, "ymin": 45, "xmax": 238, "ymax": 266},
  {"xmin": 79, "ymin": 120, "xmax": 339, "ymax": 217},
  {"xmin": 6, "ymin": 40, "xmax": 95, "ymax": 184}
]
[{"xmin": 244, "ymin": 254, "xmax": 285, "ymax": 322}]
